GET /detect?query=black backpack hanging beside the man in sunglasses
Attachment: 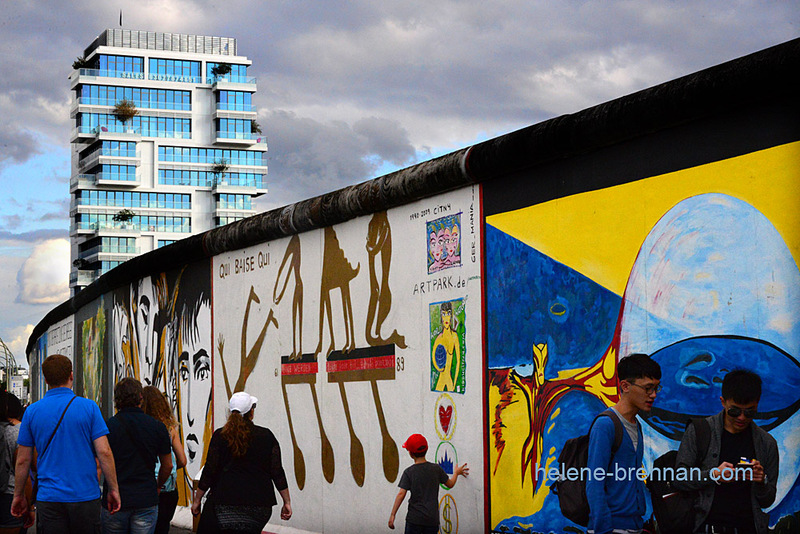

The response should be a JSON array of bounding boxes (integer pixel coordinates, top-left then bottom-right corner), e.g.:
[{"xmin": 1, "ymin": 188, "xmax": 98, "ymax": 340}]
[{"xmin": 647, "ymin": 419, "xmax": 711, "ymax": 534}]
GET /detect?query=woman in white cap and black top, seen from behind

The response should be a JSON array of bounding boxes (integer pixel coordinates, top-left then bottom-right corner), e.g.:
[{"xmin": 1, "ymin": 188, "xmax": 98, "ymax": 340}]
[{"xmin": 192, "ymin": 391, "xmax": 292, "ymax": 534}]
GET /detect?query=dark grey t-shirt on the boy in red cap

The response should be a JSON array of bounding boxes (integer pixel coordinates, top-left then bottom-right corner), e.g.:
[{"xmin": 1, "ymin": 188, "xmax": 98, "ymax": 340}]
[{"xmin": 399, "ymin": 462, "xmax": 449, "ymax": 527}]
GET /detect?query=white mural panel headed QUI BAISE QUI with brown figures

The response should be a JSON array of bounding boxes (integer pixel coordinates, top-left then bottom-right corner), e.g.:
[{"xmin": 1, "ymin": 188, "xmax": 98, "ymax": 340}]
[{"xmin": 212, "ymin": 190, "xmax": 482, "ymax": 530}]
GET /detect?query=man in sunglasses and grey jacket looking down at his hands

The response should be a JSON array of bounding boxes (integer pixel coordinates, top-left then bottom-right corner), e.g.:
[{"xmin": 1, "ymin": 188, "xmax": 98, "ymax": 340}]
[{"xmin": 675, "ymin": 370, "xmax": 778, "ymax": 534}]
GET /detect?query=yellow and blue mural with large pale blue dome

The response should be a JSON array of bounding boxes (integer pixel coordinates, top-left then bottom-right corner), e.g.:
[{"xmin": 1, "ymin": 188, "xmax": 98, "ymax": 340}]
[{"xmin": 486, "ymin": 145, "xmax": 800, "ymax": 532}]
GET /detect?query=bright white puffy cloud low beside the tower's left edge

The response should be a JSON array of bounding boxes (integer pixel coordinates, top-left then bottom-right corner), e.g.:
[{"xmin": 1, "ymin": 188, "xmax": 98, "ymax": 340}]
[{"xmin": 17, "ymin": 239, "xmax": 70, "ymax": 305}]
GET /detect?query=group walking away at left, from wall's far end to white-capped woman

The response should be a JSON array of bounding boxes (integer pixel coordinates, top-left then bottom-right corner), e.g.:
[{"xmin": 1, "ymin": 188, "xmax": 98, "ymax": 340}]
[{"xmin": 8, "ymin": 354, "xmax": 292, "ymax": 534}]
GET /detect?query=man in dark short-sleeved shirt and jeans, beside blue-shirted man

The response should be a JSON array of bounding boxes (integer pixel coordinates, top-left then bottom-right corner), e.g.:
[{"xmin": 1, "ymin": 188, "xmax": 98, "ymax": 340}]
[{"xmin": 103, "ymin": 377, "xmax": 172, "ymax": 534}]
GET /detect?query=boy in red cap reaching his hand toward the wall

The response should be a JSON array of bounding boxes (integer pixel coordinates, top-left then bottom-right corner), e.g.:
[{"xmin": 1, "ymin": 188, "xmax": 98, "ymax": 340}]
[{"xmin": 389, "ymin": 434, "xmax": 469, "ymax": 534}]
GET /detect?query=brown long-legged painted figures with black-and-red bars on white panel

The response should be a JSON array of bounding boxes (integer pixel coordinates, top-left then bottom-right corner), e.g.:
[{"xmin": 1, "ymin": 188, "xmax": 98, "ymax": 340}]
[{"xmin": 215, "ymin": 212, "xmax": 406, "ymax": 489}]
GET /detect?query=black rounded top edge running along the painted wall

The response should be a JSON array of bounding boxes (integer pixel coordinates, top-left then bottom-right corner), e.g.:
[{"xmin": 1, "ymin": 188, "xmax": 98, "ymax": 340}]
[{"xmin": 27, "ymin": 39, "xmax": 800, "ymax": 353}]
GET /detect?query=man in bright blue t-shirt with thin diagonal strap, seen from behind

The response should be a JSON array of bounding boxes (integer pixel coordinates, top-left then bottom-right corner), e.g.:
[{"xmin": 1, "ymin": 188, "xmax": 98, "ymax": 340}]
[{"xmin": 11, "ymin": 354, "xmax": 120, "ymax": 533}]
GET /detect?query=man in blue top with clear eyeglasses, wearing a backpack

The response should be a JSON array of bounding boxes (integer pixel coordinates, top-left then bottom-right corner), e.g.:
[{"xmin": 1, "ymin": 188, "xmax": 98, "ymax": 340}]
[{"xmin": 586, "ymin": 354, "xmax": 661, "ymax": 534}]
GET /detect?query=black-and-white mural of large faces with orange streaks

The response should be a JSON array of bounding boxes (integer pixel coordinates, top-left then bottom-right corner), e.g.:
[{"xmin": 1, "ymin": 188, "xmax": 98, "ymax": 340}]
[{"xmin": 111, "ymin": 261, "xmax": 213, "ymax": 503}]
